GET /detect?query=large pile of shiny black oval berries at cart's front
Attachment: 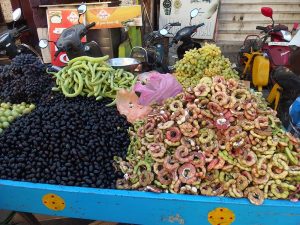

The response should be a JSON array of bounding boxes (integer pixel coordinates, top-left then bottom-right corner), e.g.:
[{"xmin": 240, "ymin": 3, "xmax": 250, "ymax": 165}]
[{"xmin": 0, "ymin": 94, "xmax": 130, "ymax": 188}]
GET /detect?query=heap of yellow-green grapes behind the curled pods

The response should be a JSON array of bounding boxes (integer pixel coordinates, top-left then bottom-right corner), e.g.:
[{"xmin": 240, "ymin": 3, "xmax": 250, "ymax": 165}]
[{"xmin": 175, "ymin": 43, "xmax": 239, "ymax": 88}]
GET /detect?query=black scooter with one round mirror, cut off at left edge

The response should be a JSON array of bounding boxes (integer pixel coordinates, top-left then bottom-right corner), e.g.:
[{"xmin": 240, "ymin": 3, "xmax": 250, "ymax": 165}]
[{"xmin": 0, "ymin": 8, "xmax": 43, "ymax": 62}]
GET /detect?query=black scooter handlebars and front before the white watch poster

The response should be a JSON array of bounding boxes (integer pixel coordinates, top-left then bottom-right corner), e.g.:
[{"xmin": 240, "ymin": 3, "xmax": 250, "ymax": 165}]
[{"xmin": 169, "ymin": 0, "xmax": 219, "ymax": 60}]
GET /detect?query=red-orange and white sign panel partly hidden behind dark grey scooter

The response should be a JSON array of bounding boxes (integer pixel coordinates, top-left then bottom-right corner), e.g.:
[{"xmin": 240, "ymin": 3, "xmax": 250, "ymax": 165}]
[{"xmin": 47, "ymin": 8, "xmax": 86, "ymax": 66}]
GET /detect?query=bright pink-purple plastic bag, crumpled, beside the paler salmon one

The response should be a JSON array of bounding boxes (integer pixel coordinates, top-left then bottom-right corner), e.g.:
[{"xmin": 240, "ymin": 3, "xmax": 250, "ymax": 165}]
[{"xmin": 134, "ymin": 72, "xmax": 182, "ymax": 105}]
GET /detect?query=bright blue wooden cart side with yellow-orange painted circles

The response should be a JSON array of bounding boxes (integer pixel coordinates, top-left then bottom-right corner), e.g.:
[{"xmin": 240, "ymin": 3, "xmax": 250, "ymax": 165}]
[{"xmin": 0, "ymin": 180, "xmax": 300, "ymax": 225}]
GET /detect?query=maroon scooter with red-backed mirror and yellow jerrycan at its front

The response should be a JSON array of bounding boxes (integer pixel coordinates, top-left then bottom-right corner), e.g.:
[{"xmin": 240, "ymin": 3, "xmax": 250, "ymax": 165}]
[{"xmin": 239, "ymin": 7, "xmax": 298, "ymax": 91}]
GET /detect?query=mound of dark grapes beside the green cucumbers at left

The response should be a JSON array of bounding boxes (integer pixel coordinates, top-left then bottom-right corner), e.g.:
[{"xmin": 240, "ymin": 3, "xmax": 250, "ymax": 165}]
[{"xmin": 0, "ymin": 54, "xmax": 54, "ymax": 103}]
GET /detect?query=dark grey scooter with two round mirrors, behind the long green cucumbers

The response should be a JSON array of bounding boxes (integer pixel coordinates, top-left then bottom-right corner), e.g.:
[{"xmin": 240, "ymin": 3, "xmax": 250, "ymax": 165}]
[{"xmin": 39, "ymin": 4, "xmax": 103, "ymax": 60}]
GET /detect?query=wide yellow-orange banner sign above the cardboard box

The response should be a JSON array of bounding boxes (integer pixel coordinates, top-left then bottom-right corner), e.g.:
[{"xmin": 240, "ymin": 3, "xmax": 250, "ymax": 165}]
[{"xmin": 86, "ymin": 5, "xmax": 142, "ymax": 29}]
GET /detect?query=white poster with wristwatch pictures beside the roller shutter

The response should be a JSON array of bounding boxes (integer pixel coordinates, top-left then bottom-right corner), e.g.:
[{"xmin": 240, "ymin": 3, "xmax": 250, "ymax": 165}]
[{"xmin": 159, "ymin": 0, "xmax": 218, "ymax": 39}]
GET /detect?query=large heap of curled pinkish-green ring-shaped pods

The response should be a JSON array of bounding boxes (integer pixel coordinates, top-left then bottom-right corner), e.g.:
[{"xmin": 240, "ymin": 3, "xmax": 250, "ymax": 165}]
[{"xmin": 115, "ymin": 76, "xmax": 300, "ymax": 205}]
